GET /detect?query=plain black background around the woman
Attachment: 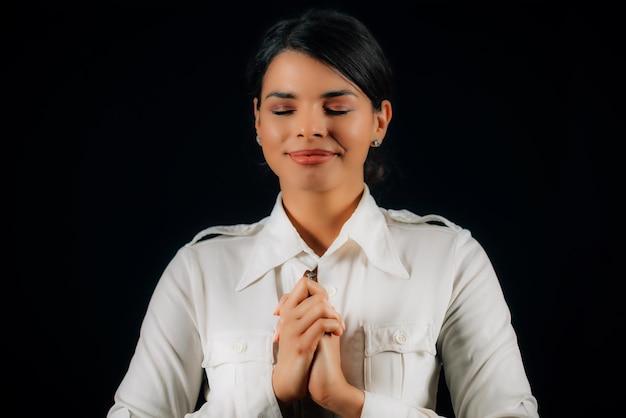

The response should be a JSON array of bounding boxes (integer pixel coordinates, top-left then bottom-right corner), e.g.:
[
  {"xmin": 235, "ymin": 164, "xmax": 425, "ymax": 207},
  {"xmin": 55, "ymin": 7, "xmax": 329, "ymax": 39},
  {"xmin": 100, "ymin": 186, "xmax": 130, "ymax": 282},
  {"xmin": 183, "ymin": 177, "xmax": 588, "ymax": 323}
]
[{"xmin": 7, "ymin": 1, "xmax": 624, "ymax": 417}]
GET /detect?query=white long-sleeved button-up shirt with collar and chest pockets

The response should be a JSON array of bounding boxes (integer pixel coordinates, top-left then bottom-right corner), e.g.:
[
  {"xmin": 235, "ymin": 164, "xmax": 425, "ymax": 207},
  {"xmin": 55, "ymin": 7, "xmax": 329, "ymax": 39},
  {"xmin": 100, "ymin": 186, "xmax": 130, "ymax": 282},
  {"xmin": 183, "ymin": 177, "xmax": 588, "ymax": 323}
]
[{"xmin": 108, "ymin": 186, "xmax": 538, "ymax": 418}]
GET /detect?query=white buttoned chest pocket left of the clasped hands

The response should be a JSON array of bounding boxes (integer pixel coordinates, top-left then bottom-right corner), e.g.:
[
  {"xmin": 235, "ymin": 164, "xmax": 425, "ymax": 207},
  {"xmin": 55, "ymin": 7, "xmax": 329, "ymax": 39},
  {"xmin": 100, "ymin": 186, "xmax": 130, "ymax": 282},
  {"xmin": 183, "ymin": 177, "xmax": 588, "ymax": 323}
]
[{"xmin": 202, "ymin": 332, "xmax": 274, "ymax": 389}]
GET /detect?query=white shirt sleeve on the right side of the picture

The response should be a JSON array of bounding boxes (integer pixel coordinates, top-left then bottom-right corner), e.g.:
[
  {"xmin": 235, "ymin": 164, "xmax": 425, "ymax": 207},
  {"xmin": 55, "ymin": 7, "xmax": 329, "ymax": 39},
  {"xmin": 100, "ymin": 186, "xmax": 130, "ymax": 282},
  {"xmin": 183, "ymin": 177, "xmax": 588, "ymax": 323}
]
[{"xmin": 438, "ymin": 230, "xmax": 539, "ymax": 418}]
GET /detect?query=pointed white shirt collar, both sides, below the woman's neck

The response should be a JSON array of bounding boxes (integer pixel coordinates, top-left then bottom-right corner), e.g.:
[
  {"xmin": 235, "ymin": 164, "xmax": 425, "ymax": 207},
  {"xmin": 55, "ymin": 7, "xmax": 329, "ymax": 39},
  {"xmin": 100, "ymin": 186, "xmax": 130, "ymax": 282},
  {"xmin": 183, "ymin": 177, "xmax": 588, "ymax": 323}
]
[{"xmin": 236, "ymin": 185, "xmax": 409, "ymax": 291}]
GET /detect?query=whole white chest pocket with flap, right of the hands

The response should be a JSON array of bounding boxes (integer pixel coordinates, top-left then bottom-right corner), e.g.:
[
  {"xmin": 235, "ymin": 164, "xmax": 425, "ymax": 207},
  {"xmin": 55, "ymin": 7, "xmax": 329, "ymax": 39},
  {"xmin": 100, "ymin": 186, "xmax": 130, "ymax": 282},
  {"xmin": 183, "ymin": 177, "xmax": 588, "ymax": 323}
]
[{"xmin": 363, "ymin": 322, "xmax": 440, "ymax": 406}]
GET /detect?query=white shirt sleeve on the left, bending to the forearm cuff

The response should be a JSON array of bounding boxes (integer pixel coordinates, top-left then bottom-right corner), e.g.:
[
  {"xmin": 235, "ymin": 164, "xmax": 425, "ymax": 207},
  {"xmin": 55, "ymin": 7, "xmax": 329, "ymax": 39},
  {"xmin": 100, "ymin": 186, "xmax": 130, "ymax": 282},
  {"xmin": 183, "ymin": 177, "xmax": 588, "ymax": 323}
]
[{"xmin": 107, "ymin": 249, "xmax": 281, "ymax": 418}]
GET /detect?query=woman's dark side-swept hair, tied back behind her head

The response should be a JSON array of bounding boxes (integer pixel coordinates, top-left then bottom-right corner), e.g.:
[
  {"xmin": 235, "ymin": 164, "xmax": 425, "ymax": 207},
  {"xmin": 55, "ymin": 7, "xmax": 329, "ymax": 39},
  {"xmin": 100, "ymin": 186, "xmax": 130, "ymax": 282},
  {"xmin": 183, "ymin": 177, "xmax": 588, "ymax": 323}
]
[{"xmin": 248, "ymin": 9, "xmax": 392, "ymax": 184}]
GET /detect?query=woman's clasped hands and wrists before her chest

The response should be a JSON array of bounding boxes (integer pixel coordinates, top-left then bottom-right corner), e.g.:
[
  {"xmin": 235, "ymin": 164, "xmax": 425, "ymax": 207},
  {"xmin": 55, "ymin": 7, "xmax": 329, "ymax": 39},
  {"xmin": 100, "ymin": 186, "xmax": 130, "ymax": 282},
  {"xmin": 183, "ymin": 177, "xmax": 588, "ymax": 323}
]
[{"xmin": 272, "ymin": 275, "xmax": 364, "ymax": 416}]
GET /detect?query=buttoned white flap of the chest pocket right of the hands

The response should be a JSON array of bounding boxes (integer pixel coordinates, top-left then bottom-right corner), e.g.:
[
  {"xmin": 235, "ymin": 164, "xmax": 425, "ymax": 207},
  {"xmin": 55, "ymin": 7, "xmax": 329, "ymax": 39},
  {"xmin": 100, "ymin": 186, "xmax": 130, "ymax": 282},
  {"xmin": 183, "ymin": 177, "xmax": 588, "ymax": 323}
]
[{"xmin": 364, "ymin": 322, "xmax": 437, "ymax": 357}]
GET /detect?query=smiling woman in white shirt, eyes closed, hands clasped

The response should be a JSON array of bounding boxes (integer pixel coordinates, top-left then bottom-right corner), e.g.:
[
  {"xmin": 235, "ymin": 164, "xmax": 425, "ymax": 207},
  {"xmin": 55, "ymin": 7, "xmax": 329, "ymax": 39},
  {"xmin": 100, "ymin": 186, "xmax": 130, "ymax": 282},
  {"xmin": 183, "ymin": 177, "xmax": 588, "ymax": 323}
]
[{"xmin": 108, "ymin": 10, "xmax": 538, "ymax": 418}]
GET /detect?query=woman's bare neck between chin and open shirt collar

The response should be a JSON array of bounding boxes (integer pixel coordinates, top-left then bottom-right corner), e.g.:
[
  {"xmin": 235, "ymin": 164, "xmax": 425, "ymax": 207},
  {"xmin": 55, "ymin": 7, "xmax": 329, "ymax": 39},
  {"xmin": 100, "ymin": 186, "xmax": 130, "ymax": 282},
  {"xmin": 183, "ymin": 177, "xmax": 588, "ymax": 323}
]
[{"xmin": 283, "ymin": 188, "xmax": 363, "ymax": 256}]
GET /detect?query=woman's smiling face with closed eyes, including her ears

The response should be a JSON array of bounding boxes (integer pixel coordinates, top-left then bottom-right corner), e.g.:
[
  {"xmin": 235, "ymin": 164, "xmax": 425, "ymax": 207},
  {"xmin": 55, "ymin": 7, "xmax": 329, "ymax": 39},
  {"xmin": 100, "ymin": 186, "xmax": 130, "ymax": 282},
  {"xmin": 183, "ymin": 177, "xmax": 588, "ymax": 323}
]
[{"xmin": 254, "ymin": 51, "xmax": 391, "ymax": 192}]
